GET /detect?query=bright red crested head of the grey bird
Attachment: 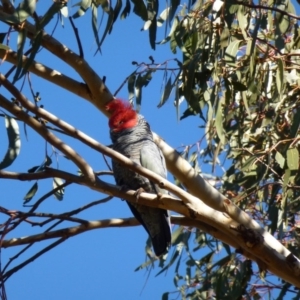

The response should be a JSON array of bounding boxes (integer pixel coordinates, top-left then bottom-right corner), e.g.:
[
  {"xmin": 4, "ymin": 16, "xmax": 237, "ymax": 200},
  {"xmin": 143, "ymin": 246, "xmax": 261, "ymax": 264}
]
[{"xmin": 106, "ymin": 99, "xmax": 138, "ymax": 132}]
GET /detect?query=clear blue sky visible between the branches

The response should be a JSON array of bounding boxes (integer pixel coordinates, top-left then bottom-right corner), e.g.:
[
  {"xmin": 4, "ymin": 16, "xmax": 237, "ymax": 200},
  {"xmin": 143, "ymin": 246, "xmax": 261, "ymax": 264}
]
[{"xmin": 0, "ymin": 1, "xmax": 206, "ymax": 300}]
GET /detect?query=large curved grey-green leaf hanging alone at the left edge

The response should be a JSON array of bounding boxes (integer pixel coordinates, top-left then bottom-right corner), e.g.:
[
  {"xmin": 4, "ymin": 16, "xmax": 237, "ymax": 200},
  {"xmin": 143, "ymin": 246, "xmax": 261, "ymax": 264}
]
[{"xmin": 0, "ymin": 116, "xmax": 21, "ymax": 170}]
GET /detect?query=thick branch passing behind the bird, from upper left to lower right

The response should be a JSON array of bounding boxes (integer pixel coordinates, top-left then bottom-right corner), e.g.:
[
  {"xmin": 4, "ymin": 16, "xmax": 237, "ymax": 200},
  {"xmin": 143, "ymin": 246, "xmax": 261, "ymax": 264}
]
[{"xmin": 1, "ymin": 11, "xmax": 290, "ymax": 264}]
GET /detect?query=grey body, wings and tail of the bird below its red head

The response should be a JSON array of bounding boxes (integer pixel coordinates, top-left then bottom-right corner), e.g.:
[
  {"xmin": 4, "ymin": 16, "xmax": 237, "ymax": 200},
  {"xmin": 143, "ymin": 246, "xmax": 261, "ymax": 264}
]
[{"xmin": 110, "ymin": 115, "xmax": 171, "ymax": 256}]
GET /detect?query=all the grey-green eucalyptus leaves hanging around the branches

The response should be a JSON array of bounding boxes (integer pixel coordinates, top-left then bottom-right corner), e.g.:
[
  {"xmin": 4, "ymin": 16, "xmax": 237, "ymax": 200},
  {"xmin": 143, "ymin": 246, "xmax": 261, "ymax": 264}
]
[{"xmin": 0, "ymin": 0, "xmax": 300, "ymax": 299}]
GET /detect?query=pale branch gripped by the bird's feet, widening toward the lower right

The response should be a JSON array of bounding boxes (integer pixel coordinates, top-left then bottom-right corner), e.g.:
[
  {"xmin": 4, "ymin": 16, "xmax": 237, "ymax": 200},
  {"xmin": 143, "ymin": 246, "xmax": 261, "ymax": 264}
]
[{"xmin": 1, "ymin": 169, "xmax": 300, "ymax": 286}]
